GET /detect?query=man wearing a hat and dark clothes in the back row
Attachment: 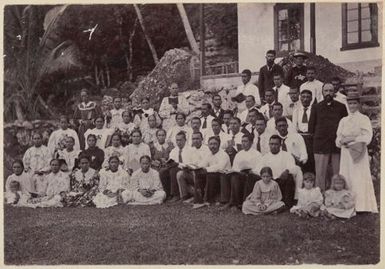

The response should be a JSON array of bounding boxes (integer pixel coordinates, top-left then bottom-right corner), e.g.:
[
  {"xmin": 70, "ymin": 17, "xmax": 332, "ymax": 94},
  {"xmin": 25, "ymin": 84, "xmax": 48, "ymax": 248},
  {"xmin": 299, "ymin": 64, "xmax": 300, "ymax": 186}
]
[{"xmin": 285, "ymin": 52, "xmax": 307, "ymax": 88}]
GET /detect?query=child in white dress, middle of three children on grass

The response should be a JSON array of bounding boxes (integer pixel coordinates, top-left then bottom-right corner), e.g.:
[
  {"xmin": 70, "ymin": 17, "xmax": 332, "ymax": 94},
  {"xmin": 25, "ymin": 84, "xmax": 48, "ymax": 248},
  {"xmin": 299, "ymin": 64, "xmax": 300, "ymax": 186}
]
[{"xmin": 290, "ymin": 173, "xmax": 323, "ymax": 217}]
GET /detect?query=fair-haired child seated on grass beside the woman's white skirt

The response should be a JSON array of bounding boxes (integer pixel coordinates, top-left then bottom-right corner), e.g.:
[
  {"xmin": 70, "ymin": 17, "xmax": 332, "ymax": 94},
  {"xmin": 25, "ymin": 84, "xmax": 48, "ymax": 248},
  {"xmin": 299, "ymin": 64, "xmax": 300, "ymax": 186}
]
[{"xmin": 321, "ymin": 175, "xmax": 356, "ymax": 219}]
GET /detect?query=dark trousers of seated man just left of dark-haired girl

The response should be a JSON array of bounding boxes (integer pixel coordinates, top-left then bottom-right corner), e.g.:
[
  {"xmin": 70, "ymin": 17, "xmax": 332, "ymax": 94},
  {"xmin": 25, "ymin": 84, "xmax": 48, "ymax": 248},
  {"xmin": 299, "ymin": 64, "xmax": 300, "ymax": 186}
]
[{"xmin": 229, "ymin": 173, "xmax": 261, "ymax": 207}]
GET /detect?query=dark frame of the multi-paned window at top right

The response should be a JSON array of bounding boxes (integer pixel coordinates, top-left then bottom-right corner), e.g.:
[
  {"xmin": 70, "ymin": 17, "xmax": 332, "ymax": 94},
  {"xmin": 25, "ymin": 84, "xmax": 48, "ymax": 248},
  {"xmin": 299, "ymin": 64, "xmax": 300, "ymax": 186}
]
[{"xmin": 340, "ymin": 3, "xmax": 380, "ymax": 51}]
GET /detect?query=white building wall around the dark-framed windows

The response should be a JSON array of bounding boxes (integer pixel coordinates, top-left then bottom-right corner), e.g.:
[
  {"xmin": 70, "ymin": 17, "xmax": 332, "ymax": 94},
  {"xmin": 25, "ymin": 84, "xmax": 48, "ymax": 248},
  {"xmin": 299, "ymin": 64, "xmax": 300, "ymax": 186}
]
[{"xmin": 238, "ymin": 3, "xmax": 382, "ymax": 72}]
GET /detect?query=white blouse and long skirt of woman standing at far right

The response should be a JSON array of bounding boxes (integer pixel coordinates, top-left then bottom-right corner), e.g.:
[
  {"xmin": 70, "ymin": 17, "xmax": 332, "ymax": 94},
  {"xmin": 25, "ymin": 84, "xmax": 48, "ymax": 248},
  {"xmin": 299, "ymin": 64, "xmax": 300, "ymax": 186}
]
[{"xmin": 336, "ymin": 112, "xmax": 378, "ymax": 213}]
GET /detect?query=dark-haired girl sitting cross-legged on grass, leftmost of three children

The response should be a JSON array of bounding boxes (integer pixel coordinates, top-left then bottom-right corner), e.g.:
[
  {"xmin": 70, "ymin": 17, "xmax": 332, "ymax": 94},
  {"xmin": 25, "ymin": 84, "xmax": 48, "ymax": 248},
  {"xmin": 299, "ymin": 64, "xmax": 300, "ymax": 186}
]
[{"xmin": 242, "ymin": 167, "xmax": 285, "ymax": 215}]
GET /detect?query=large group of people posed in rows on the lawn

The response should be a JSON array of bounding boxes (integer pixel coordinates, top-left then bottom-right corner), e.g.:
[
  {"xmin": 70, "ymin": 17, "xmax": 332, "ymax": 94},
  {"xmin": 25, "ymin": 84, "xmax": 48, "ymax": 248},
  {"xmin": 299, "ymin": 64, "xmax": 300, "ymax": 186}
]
[{"xmin": 6, "ymin": 51, "xmax": 377, "ymax": 218}]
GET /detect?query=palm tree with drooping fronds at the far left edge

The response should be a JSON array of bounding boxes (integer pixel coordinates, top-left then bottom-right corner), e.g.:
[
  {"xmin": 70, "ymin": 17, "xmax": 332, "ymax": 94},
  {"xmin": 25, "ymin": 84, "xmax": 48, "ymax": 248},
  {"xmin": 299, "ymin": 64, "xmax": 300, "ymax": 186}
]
[{"xmin": 4, "ymin": 5, "xmax": 81, "ymax": 121}]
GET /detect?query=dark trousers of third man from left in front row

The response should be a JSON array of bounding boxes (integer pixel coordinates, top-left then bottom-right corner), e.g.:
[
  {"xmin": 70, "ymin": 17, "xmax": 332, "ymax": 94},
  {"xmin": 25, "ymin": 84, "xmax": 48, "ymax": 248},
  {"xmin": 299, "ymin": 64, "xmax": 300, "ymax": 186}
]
[{"xmin": 204, "ymin": 173, "xmax": 230, "ymax": 203}]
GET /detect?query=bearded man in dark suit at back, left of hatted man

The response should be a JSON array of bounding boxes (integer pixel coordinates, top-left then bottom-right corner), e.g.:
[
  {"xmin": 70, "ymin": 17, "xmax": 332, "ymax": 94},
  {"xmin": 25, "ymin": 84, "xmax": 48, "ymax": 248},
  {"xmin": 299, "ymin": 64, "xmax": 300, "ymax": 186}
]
[{"xmin": 258, "ymin": 50, "xmax": 284, "ymax": 100}]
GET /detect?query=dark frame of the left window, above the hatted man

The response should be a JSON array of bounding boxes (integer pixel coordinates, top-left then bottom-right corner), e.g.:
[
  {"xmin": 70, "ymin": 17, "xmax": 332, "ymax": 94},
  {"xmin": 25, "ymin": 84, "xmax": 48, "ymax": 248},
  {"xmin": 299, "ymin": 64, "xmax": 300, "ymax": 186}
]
[{"xmin": 274, "ymin": 3, "xmax": 305, "ymax": 57}]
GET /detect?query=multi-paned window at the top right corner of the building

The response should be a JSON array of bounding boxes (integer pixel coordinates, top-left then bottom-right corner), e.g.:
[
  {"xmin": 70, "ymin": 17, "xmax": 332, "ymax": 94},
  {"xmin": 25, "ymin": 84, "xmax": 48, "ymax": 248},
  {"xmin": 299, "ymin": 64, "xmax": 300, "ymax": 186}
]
[{"xmin": 341, "ymin": 3, "xmax": 379, "ymax": 50}]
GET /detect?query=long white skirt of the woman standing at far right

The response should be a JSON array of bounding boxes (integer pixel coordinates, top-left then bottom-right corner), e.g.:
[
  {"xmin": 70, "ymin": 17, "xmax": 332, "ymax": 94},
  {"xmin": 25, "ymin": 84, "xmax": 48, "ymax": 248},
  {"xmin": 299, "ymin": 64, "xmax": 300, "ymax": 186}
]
[{"xmin": 340, "ymin": 147, "xmax": 378, "ymax": 213}]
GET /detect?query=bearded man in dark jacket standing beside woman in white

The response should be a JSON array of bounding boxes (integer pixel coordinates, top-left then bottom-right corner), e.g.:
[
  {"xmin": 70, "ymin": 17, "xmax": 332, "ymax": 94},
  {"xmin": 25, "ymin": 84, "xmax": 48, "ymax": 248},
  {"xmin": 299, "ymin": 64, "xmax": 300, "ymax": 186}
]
[{"xmin": 308, "ymin": 83, "xmax": 348, "ymax": 192}]
